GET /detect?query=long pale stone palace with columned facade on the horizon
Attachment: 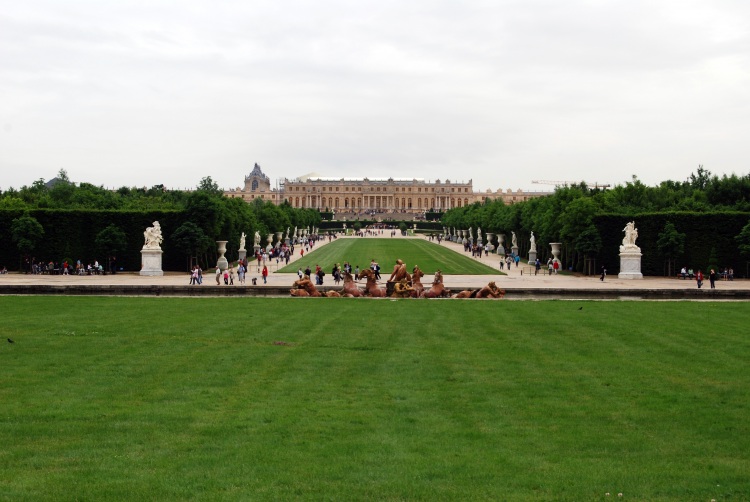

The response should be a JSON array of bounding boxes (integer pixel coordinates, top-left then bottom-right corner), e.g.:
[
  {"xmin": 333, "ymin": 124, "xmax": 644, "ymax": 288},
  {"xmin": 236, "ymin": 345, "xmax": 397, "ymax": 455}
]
[{"xmin": 224, "ymin": 164, "xmax": 551, "ymax": 213}]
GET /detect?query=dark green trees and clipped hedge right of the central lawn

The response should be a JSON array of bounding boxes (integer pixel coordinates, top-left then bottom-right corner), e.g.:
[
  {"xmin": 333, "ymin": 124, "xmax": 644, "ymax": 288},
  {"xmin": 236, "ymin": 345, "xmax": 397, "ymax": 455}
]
[{"xmin": 441, "ymin": 166, "xmax": 750, "ymax": 275}]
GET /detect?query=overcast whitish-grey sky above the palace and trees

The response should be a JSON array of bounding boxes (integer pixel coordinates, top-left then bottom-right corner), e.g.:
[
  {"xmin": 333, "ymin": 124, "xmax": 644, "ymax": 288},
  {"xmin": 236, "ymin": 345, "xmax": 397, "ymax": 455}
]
[{"xmin": 0, "ymin": 0, "xmax": 750, "ymax": 191}]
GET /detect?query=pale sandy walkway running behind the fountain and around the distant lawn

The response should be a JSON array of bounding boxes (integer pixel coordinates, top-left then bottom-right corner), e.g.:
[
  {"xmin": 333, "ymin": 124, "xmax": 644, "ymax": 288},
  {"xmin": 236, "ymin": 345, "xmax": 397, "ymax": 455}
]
[{"xmin": 0, "ymin": 231, "xmax": 750, "ymax": 291}]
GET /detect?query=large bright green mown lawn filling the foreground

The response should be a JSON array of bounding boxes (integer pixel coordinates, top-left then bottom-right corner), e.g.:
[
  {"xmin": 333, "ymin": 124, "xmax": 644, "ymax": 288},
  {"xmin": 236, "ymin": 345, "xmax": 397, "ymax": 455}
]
[{"xmin": 0, "ymin": 297, "xmax": 750, "ymax": 501}]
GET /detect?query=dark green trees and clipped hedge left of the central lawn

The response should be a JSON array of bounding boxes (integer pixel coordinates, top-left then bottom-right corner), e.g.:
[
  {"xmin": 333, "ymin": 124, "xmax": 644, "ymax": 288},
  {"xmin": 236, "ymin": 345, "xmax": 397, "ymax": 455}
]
[{"xmin": 0, "ymin": 174, "xmax": 321, "ymax": 270}]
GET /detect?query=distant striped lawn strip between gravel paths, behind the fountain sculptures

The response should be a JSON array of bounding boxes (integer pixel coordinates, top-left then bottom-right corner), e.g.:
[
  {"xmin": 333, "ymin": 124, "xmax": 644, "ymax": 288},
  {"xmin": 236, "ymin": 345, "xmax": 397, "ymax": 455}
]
[{"xmin": 280, "ymin": 237, "xmax": 501, "ymax": 279}]
